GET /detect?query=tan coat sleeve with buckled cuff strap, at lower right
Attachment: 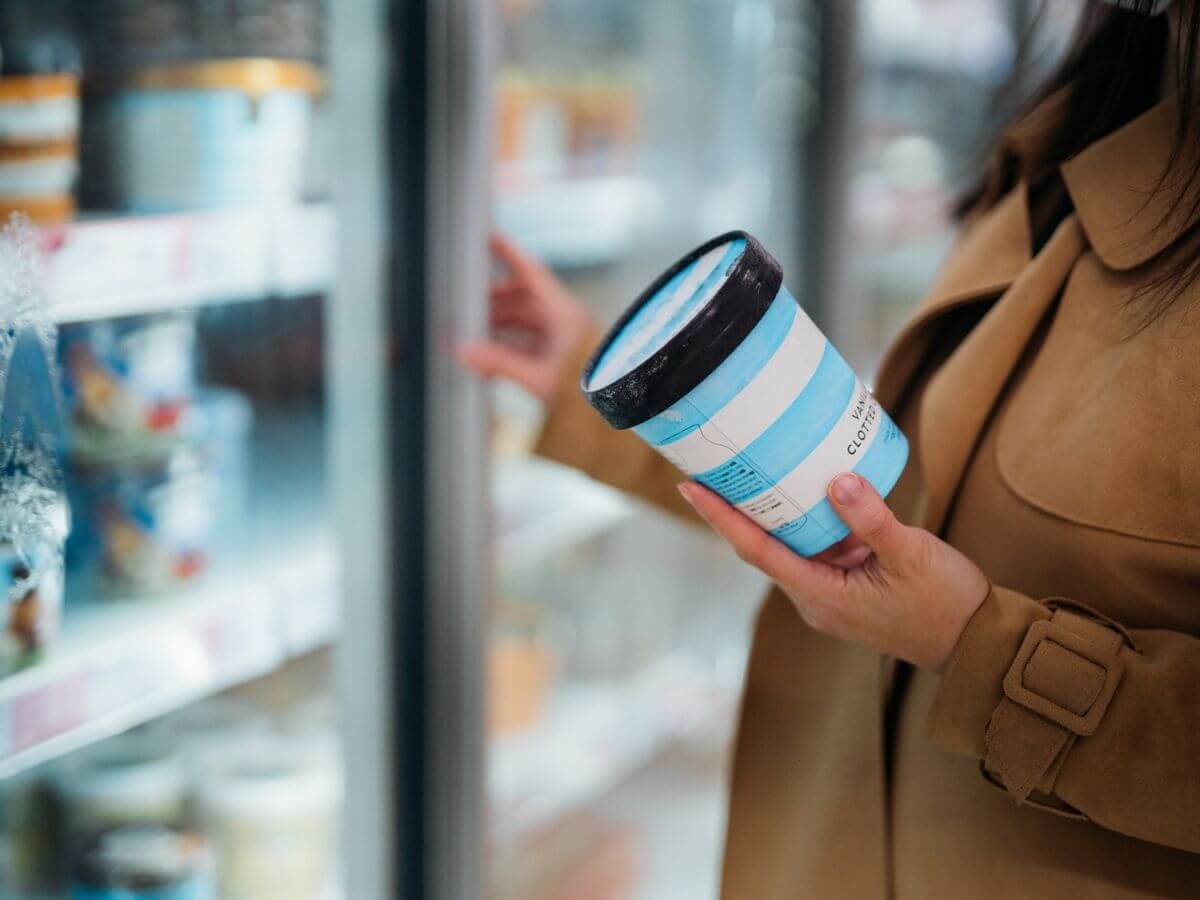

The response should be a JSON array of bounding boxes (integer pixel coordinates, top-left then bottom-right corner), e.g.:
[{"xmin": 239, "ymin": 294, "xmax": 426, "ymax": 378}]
[{"xmin": 928, "ymin": 587, "xmax": 1200, "ymax": 853}]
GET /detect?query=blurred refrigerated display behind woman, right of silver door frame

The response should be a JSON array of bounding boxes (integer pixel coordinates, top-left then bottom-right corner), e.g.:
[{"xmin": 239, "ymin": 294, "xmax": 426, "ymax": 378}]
[{"xmin": 488, "ymin": 0, "xmax": 1073, "ymax": 899}]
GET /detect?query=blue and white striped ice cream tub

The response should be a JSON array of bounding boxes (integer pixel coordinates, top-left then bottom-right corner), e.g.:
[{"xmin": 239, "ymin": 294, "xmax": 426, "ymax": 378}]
[{"xmin": 589, "ymin": 239, "xmax": 908, "ymax": 556}]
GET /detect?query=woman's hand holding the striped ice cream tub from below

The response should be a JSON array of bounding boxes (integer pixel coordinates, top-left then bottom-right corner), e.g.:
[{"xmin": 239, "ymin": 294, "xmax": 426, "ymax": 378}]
[{"xmin": 679, "ymin": 474, "xmax": 990, "ymax": 671}]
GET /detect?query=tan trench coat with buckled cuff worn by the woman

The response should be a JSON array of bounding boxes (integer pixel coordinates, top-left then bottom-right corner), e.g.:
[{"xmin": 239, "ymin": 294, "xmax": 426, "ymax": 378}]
[{"xmin": 540, "ymin": 98, "xmax": 1200, "ymax": 900}]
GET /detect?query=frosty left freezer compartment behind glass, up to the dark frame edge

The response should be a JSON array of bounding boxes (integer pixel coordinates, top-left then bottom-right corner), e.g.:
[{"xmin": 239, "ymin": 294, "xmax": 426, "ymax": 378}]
[{"xmin": 0, "ymin": 0, "xmax": 446, "ymax": 900}]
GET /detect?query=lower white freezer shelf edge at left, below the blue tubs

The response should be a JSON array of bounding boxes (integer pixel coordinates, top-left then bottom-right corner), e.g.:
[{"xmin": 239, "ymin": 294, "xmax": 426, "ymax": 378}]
[{"xmin": 0, "ymin": 536, "xmax": 338, "ymax": 779}]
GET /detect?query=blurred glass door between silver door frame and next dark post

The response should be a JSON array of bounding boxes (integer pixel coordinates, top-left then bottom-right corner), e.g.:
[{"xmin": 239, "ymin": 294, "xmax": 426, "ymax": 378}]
[{"xmin": 487, "ymin": 0, "xmax": 820, "ymax": 900}]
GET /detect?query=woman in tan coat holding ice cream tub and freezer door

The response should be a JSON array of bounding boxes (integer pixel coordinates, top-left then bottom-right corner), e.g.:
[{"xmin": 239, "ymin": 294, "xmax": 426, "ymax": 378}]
[{"xmin": 466, "ymin": 0, "xmax": 1200, "ymax": 900}]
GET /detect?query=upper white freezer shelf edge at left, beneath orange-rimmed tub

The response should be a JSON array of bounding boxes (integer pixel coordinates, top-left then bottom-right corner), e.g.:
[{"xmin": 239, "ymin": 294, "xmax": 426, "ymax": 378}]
[{"xmin": 41, "ymin": 203, "xmax": 335, "ymax": 322}]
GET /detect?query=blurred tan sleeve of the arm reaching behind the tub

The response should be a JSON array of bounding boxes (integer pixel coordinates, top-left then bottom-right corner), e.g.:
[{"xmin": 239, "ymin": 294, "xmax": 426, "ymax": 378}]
[{"xmin": 534, "ymin": 331, "xmax": 700, "ymax": 522}]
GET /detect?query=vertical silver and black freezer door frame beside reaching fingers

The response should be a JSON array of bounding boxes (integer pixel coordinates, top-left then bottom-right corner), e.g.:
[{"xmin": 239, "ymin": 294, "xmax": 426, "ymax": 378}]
[{"xmin": 330, "ymin": 0, "xmax": 490, "ymax": 900}]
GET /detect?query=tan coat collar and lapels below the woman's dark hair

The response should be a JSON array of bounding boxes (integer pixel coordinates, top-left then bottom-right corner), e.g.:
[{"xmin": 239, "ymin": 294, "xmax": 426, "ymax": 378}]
[{"xmin": 878, "ymin": 86, "xmax": 1183, "ymax": 533}]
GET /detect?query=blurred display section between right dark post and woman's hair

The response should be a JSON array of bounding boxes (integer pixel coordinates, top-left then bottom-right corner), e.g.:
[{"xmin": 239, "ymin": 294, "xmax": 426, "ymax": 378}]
[{"xmin": 822, "ymin": 0, "xmax": 1080, "ymax": 372}]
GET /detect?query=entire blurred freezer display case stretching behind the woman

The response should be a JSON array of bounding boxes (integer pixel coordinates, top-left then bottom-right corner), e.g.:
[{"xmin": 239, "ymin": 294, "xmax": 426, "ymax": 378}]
[{"xmin": 0, "ymin": 0, "xmax": 1094, "ymax": 900}]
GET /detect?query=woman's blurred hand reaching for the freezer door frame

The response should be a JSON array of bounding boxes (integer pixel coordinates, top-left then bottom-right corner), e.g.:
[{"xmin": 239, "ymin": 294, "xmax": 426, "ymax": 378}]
[{"xmin": 460, "ymin": 234, "xmax": 592, "ymax": 402}]
